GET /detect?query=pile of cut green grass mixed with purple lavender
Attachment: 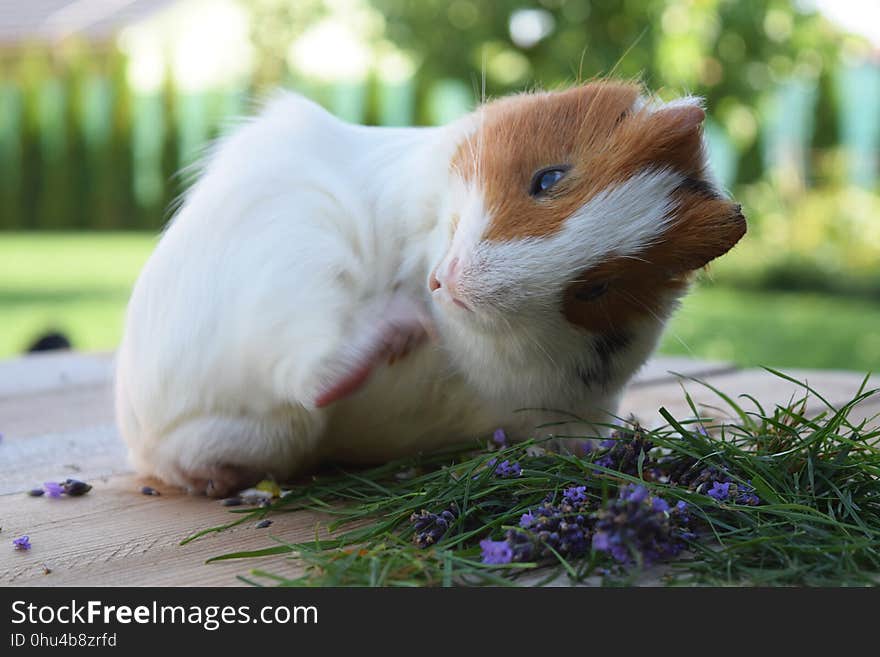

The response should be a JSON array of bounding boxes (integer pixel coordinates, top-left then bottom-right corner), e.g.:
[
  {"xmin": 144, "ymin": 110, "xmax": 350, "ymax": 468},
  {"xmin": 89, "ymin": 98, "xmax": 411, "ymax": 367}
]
[{"xmin": 187, "ymin": 371, "xmax": 880, "ymax": 586}]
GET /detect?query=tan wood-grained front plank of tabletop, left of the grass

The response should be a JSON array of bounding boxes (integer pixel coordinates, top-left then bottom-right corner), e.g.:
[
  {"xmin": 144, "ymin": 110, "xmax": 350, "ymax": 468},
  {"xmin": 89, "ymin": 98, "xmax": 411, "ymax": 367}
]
[{"xmin": 0, "ymin": 475, "xmax": 321, "ymax": 586}]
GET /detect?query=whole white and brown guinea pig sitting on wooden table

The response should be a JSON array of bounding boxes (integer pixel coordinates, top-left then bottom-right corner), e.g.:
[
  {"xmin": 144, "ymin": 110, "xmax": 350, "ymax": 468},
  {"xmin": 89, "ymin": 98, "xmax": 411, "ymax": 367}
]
[{"xmin": 116, "ymin": 81, "xmax": 746, "ymax": 495}]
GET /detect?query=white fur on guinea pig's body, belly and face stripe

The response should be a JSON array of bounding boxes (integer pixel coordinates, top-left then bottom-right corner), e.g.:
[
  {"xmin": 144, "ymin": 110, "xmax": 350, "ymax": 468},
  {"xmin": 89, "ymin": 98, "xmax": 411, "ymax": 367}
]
[{"xmin": 116, "ymin": 89, "xmax": 696, "ymax": 487}]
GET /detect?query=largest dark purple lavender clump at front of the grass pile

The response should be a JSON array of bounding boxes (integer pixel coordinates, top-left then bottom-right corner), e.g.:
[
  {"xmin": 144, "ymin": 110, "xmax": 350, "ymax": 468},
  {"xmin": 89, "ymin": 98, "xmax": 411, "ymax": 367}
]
[{"xmin": 592, "ymin": 484, "xmax": 694, "ymax": 563}]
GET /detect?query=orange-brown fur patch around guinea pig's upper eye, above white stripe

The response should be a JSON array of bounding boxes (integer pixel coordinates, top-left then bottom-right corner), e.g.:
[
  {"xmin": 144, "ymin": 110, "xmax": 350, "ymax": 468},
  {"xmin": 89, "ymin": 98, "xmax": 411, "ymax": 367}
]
[{"xmin": 453, "ymin": 82, "xmax": 703, "ymax": 241}]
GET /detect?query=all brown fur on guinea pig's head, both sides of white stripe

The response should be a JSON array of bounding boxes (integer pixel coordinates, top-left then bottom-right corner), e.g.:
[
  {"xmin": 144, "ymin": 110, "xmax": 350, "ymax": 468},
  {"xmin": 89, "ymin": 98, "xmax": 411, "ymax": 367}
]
[{"xmin": 453, "ymin": 81, "xmax": 746, "ymax": 334}]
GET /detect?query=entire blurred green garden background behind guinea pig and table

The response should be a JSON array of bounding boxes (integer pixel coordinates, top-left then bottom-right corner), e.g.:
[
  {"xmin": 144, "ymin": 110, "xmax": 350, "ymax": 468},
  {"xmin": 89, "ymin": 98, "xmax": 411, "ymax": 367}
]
[{"xmin": 0, "ymin": 0, "xmax": 880, "ymax": 370}]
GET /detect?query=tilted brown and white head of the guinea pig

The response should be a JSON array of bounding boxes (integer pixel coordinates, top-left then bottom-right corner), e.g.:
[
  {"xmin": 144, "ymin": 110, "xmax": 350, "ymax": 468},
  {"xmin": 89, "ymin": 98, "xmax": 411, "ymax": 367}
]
[{"xmin": 428, "ymin": 81, "xmax": 746, "ymax": 333}]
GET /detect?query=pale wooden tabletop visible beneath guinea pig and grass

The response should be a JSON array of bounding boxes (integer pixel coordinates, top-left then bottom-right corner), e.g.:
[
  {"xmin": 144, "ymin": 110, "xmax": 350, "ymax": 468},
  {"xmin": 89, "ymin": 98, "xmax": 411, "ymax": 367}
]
[{"xmin": 0, "ymin": 353, "xmax": 880, "ymax": 586}]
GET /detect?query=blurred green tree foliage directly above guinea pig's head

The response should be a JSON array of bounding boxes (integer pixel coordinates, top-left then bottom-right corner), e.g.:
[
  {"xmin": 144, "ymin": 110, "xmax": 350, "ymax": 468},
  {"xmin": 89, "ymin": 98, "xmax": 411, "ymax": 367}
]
[{"xmin": 360, "ymin": 0, "xmax": 840, "ymax": 180}]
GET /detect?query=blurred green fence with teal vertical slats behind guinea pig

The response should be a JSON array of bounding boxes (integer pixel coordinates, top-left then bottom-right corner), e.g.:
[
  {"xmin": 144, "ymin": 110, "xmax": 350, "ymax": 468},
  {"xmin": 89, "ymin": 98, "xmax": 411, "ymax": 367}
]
[{"xmin": 0, "ymin": 42, "xmax": 880, "ymax": 230}]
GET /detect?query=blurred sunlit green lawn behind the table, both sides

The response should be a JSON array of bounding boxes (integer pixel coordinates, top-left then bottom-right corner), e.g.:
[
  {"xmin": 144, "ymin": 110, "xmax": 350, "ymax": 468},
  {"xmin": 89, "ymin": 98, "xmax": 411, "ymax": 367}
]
[{"xmin": 0, "ymin": 233, "xmax": 880, "ymax": 371}]
